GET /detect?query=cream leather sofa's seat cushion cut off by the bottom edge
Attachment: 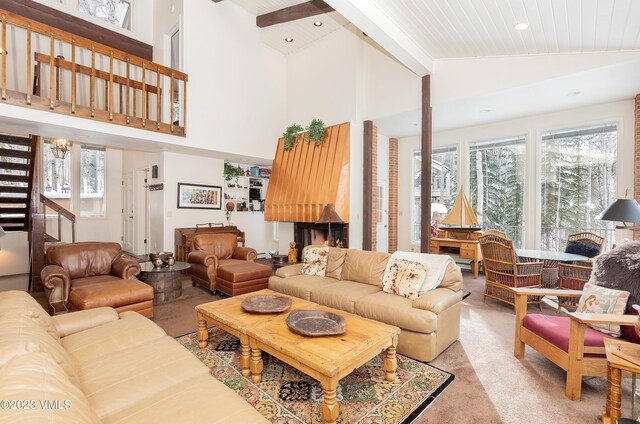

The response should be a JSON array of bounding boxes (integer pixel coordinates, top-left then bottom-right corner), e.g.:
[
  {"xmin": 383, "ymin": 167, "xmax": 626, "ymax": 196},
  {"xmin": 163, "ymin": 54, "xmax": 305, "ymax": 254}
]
[{"xmin": 102, "ymin": 374, "xmax": 269, "ymax": 424}]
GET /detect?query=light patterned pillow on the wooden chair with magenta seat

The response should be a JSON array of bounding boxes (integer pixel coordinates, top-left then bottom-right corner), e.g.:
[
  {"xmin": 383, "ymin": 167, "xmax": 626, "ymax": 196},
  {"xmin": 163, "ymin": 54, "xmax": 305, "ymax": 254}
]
[{"xmin": 576, "ymin": 283, "xmax": 629, "ymax": 337}]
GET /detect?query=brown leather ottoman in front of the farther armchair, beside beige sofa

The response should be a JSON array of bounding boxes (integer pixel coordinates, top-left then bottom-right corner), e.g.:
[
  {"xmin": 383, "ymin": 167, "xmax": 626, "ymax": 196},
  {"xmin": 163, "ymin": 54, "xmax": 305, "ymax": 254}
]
[{"xmin": 216, "ymin": 262, "xmax": 271, "ymax": 296}]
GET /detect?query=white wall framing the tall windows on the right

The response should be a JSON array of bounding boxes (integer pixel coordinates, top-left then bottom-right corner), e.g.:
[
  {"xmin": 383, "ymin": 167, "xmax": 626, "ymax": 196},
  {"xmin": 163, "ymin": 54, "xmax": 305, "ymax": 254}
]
[{"xmin": 398, "ymin": 100, "xmax": 635, "ymax": 250}]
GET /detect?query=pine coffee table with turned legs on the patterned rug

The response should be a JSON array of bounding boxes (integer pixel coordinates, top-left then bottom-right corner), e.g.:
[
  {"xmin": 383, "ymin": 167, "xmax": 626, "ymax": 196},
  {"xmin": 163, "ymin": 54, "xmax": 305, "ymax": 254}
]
[{"xmin": 196, "ymin": 290, "xmax": 400, "ymax": 423}]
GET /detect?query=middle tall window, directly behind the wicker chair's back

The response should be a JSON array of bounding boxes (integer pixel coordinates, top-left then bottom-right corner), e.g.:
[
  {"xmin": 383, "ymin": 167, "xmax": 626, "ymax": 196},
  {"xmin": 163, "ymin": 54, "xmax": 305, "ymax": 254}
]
[{"xmin": 469, "ymin": 137, "xmax": 525, "ymax": 247}]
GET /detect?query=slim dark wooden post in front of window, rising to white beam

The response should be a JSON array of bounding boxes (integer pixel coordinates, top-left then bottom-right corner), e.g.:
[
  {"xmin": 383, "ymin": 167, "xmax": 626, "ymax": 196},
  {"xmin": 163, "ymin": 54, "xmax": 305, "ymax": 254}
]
[{"xmin": 420, "ymin": 75, "xmax": 433, "ymax": 253}]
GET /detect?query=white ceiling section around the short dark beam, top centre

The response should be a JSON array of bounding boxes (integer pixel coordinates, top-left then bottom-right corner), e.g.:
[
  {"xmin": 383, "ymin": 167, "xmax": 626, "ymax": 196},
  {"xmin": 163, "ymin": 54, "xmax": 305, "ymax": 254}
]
[{"xmin": 232, "ymin": 0, "xmax": 349, "ymax": 55}]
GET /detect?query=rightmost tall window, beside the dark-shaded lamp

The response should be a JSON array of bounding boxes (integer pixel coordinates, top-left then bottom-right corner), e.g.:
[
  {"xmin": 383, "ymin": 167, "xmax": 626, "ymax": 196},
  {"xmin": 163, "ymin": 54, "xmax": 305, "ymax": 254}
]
[{"xmin": 540, "ymin": 125, "xmax": 618, "ymax": 250}]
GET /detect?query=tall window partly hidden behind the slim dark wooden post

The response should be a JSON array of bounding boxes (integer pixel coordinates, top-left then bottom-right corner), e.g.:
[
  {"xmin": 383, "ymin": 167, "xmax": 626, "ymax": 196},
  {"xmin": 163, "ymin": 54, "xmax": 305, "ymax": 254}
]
[{"xmin": 412, "ymin": 146, "xmax": 458, "ymax": 243}]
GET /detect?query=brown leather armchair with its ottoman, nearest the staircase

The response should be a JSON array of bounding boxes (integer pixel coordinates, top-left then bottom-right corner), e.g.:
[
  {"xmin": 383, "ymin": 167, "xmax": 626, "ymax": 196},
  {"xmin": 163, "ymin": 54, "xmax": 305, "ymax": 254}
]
[{"xmin": 40, "ymin": 242, "xmax": 153, "ymax": 317}]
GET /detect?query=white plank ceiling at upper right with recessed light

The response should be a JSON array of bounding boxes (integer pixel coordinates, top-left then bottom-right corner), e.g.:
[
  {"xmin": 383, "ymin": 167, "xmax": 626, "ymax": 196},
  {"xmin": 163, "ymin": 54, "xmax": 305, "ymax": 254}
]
[{"xmin": 370, "ymin": 0, "xmax": 640, "ymax": 59}]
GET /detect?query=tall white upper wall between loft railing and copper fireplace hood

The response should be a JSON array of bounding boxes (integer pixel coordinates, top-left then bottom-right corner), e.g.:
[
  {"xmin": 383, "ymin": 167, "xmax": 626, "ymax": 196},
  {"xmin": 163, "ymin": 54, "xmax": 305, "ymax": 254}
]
[{"xmin": 183, "ymin": 0, "xmax": 286, "ymax": 159}]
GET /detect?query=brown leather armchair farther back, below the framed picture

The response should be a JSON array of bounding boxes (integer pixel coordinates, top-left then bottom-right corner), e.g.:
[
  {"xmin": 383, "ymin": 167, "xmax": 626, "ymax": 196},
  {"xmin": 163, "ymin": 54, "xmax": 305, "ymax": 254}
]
[{"xmin": 187, "ymin": 233, "xmax": 257, "ymax": 294}]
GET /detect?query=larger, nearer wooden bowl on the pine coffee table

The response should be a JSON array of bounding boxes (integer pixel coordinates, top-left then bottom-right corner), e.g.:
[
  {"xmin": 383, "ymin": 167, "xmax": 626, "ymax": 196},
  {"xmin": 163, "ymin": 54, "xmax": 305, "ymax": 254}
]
[{"xmin": 287, "ymin": 309, "xmax": 347, "ymax": 337}]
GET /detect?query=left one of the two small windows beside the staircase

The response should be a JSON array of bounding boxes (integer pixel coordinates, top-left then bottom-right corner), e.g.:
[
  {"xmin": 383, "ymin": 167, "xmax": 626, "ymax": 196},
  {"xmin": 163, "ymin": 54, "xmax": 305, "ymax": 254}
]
[{"xmin": 42, "ymin": 140, "xmax": 72, "ymax": 210}]
